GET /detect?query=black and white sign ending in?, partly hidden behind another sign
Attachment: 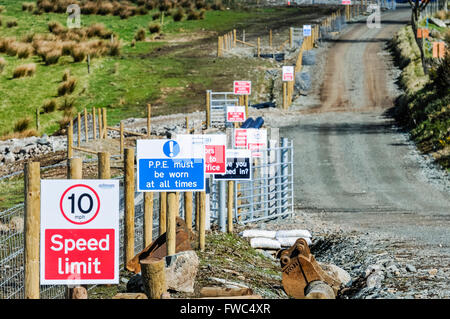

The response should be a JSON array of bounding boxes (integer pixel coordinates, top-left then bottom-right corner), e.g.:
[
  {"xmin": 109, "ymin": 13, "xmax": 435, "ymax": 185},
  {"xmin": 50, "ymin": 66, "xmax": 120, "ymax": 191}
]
[{"xmin": 214, "ymin": 149, "xmax": 252, "ymax": 181}]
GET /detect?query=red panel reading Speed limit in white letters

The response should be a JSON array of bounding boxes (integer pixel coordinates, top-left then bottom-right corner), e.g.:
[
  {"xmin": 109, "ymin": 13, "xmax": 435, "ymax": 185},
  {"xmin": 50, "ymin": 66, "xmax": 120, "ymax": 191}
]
[{"xmin": 44, "ymin": 229, "xmax": 115, "ymax": 280}]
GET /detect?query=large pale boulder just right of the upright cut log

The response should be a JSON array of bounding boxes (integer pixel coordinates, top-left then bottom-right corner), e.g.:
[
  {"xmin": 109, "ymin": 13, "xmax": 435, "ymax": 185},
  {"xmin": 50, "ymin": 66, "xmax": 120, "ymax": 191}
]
[{"xmin": 165, "ymin": 250, "xmax": 200, "ymax": 293}]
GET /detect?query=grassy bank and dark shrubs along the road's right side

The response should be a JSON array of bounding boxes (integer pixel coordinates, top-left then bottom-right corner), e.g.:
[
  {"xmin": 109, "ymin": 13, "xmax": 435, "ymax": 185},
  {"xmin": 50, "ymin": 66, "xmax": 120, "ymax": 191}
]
[{"xmin": 393, "ymin": 20, "xmax": 450, "ymax": 170}]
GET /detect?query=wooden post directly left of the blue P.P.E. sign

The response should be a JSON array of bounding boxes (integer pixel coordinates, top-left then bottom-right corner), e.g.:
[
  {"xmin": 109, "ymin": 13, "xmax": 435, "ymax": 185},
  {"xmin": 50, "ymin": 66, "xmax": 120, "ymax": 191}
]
[{"xmin": 124, "ymin": 148, "xmax": 134, "ymax": 267}]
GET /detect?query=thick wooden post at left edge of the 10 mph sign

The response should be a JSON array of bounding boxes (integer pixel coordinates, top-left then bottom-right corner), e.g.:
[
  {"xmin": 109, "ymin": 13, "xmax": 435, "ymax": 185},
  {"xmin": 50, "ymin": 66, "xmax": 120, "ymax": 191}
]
[{"xmin": 24, "ymin": 162, "xmax": 41, "ymax": 299}]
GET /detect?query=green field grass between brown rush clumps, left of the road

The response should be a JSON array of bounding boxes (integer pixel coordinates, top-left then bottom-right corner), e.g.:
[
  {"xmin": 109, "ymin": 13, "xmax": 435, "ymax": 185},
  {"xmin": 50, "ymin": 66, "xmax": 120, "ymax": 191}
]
[{"xmin": 0, "ymin": 0, "xmax": 284, "ymax": 135}]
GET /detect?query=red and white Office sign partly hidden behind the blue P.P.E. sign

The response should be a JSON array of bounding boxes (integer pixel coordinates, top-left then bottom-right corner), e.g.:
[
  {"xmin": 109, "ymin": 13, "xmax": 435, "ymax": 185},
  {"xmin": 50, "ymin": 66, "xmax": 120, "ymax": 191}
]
[{"xmin": 177, "ymin": 134, "xmax": 227, "ymax": 174}]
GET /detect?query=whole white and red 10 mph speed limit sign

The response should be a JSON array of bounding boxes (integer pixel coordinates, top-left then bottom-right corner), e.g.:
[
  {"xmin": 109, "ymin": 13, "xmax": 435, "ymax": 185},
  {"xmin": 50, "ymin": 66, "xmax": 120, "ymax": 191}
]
[{"xmin": 40, "ymin": 180, "xmax": 120, "ymax": 285}]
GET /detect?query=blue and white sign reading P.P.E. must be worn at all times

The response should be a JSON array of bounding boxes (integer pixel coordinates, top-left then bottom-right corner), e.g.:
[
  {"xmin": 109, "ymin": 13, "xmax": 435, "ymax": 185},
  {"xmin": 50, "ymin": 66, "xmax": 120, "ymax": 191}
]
[{"xmin": 136, "ymin": 139, "xmax": 205, "ymax": 192}]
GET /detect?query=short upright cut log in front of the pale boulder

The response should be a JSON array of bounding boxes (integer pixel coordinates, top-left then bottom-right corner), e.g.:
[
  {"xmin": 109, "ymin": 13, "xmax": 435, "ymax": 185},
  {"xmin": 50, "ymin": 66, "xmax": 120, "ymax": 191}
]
[{"xmin": 139, "ymin": 257, "xmax": 167, "ymax": 299}]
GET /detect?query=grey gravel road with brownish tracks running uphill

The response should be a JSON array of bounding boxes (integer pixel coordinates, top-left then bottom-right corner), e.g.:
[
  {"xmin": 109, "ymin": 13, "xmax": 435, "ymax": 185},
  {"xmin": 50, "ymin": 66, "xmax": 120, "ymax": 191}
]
[{"xmin": 274, "ymin": 7, "xmax": 450, "ymax": 298}]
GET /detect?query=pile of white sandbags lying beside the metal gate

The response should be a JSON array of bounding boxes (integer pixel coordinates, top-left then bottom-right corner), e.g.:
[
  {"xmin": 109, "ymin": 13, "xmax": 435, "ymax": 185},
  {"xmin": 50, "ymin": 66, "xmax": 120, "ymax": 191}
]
[{"xmin": 239, "ymin": 229, "xmax": 312, "ymax": 250}]
